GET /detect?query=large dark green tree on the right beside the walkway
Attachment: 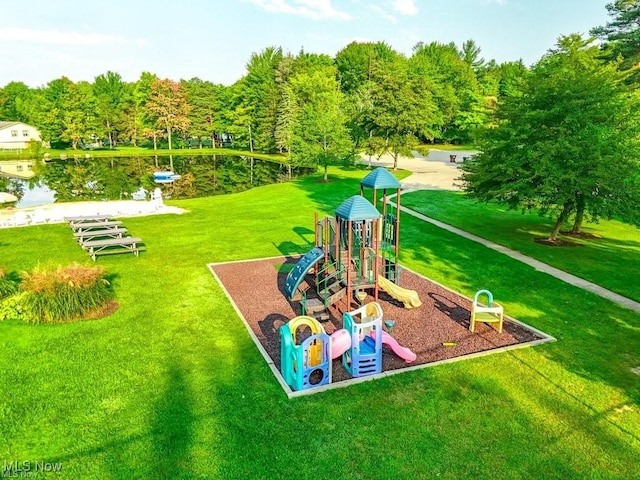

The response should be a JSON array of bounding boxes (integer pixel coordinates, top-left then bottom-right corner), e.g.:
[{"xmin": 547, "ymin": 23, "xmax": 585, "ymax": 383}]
[{"xmin": 462, "ymin": 35, "xmax": 640, "ymax": 242}]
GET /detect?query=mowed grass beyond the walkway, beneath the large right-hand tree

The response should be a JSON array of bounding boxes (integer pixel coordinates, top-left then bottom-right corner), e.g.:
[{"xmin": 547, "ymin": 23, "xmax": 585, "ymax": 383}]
[{"xmin": 402, "ymin": 190, "xmax": 640, "ymax": 301}]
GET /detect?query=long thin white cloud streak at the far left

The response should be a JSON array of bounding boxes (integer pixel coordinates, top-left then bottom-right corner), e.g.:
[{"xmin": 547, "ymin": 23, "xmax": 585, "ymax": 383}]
[{"xmin": 0, "ymin": 28, "xmax": 148, "ymax": 46}]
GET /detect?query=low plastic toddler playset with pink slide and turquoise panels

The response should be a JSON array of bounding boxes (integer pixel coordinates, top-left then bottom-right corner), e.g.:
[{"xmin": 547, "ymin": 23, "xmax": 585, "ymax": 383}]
[{"xmin": 280, "ymin": 302, "xmax": 416, "ymax": 390}]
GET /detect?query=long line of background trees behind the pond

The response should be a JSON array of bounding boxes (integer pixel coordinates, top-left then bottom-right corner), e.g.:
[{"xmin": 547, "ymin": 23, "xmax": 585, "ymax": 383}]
[{"xmin": 0, "ymin": 40, "xmax": 527, "ymax": 164}]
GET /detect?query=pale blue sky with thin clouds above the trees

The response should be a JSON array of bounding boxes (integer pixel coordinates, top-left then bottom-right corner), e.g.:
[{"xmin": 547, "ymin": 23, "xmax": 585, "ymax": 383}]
[{"xmin": 0, "ymin": 0, "xmax": 609, "ymax": 87}]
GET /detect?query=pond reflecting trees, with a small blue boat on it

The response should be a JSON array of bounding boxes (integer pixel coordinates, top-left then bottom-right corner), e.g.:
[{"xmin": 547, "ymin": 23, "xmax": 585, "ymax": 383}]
[{"xmin": 0, "ymin": 155, "xmax": 315, "ymax": 208}]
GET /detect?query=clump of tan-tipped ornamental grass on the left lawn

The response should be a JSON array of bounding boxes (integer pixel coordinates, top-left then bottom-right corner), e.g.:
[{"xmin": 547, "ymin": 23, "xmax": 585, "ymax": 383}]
[{"xmin": 20, "ymin": 263, "xmax": 114, "ymax": 323}]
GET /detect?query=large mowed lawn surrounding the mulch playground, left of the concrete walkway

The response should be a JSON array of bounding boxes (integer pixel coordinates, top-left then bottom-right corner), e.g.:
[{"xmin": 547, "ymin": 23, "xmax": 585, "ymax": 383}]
[{"xmin": 0, "ymin": 169, "xmax": 640, "ymax": 479}]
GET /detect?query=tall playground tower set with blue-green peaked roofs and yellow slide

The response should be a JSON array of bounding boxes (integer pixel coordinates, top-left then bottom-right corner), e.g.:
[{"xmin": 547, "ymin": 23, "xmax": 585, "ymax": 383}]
[{"xmin": 284, "ymin": 168, "xmax": 421, "ymax": 321}]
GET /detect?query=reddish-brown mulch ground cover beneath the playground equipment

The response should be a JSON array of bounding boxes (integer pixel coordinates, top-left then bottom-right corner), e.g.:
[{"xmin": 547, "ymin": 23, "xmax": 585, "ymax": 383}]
[{"xmin": 209, "ymin": 257, "xmax": 552, "ymax": 383}]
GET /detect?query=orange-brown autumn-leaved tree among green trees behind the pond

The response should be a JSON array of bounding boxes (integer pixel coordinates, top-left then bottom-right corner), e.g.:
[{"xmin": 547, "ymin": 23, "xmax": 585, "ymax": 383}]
[{"xmin": 145, "ymin": 79, "xmax": 190, "ymax": 150}]
